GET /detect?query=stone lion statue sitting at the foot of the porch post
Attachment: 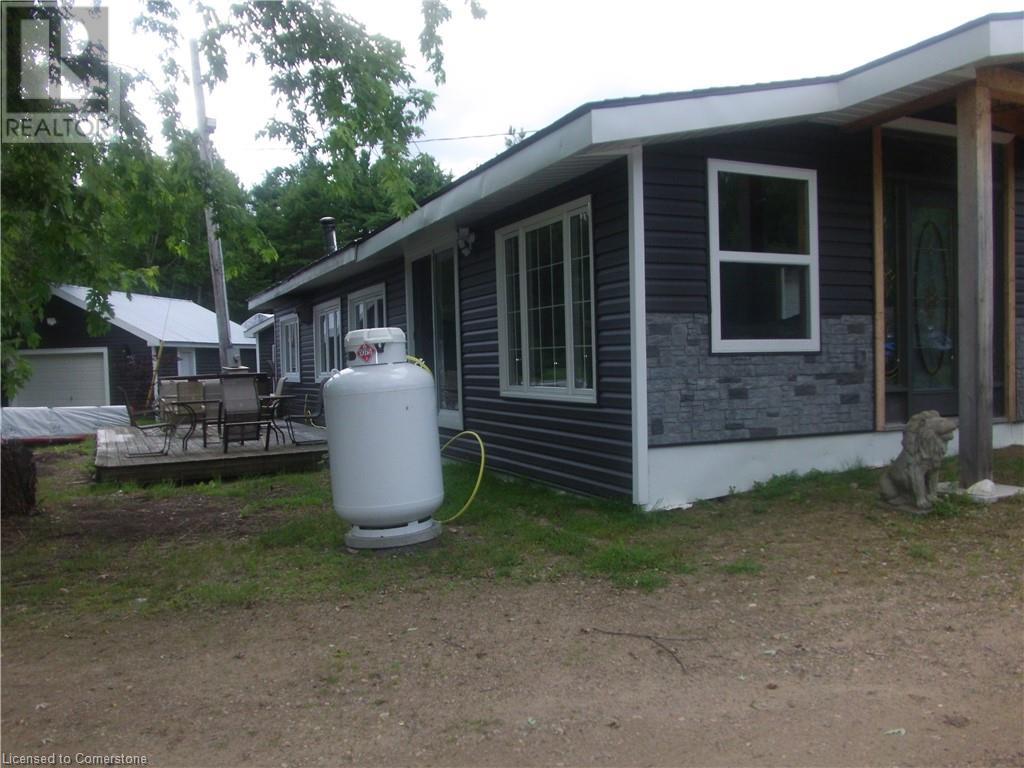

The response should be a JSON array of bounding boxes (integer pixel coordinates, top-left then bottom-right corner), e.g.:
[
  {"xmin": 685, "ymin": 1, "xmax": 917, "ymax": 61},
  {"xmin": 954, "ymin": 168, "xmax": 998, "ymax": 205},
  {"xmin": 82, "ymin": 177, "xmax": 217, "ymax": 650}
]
[{"xmin": 879, "ymin": 411, "xmax": 956, "ymax": 512}]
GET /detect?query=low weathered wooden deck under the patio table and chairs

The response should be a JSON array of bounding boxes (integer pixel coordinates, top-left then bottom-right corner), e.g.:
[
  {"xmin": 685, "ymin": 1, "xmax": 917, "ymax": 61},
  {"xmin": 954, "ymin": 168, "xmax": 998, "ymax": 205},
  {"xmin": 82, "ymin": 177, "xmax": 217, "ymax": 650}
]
[{"xmin": 96, "ymin": 425, "xmax": 327, "ymax": 483}]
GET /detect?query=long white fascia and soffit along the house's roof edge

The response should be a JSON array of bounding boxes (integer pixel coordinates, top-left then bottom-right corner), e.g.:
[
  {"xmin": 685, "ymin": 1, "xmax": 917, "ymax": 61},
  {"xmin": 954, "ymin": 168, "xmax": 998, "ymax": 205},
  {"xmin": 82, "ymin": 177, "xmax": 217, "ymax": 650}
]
[{"xmin": 249, "ymin": 13, "xmax": 1024, "ymax": 310}]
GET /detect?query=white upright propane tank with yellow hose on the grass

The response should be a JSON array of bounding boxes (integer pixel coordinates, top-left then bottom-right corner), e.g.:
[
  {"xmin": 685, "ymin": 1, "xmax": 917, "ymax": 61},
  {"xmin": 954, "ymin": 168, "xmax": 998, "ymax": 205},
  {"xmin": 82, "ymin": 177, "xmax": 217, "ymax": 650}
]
[{"xmin": 324, "ymin": 328, "xmax": 444, "ymax": 549}]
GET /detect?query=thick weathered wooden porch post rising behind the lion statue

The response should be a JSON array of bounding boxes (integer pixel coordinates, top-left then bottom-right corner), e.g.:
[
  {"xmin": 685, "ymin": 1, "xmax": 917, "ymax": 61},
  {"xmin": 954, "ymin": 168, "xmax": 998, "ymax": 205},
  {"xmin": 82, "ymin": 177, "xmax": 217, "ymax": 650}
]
[{"xmin": 956, "ymin": 84, "xmax": 992, "ymax": 487}]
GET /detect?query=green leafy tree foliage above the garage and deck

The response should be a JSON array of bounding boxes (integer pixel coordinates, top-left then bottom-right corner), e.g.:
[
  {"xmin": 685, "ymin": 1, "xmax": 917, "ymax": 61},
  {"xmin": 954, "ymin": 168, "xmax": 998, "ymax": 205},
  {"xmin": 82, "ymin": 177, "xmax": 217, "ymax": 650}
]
[{"xmin": 0, "ymin": 0, "xmax": 483, "ymax": 395}]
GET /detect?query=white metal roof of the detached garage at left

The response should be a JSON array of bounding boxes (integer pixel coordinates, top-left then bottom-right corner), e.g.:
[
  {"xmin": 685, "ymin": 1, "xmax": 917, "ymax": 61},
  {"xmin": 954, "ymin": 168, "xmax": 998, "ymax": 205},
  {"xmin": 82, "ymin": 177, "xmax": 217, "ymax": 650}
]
[{"xmin": 51, "ymin": 286, "xmax": 256, "ymax": 347}]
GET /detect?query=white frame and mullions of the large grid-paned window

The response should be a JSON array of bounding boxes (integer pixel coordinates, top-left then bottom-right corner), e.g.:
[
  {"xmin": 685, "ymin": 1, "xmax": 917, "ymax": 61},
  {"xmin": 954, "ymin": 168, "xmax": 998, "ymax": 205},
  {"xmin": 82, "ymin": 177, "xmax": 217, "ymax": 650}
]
[{"xmin": 495, "ymin": 195, "xmax": 597, "ymax": 404}]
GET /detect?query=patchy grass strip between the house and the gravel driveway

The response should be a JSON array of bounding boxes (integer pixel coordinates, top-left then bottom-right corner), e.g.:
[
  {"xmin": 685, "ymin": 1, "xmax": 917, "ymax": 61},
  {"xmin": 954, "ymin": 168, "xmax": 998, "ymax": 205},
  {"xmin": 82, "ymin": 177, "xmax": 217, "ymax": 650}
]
[{"xmin": 8, "ymin": 444, "xmax": 1024, "ymax": 621}]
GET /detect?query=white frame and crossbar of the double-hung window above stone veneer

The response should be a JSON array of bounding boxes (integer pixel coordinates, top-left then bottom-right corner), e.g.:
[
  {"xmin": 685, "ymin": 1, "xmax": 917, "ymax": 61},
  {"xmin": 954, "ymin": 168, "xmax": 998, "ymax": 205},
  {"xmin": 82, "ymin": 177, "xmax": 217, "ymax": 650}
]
[{"xmin": 708, "ymin": 160, "xmax": 821, "ymax": 353}]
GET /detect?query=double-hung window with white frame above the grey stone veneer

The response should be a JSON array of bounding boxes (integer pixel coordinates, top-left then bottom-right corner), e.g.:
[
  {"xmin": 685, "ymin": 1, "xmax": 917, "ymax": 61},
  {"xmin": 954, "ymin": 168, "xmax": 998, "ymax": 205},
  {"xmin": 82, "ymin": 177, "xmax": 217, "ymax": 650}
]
[{"xmin": 708, "ymin": 160, "xmax": 820, "ymax": 352}]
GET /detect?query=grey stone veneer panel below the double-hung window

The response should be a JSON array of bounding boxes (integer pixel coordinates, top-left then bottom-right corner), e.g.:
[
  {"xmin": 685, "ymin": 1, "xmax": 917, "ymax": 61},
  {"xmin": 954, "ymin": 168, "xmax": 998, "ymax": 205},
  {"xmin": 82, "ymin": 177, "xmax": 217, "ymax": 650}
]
[{"xmin": 647, "ymin": 313, "xmax": 872, "ymax": 446}]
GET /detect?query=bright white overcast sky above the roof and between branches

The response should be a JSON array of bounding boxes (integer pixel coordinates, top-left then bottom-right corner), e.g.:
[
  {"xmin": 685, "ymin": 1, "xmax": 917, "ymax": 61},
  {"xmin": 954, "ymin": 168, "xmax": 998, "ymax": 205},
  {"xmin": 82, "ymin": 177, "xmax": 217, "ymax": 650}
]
[{"xmin": 110, "ymin": 0, "xmax": 1024, "ymax": 185}]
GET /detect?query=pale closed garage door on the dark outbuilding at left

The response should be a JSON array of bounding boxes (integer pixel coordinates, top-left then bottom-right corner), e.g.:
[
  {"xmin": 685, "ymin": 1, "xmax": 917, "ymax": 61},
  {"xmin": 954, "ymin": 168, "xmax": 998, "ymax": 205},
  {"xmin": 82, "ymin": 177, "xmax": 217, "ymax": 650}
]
[{"xmin": 11, "ymin": 349, "xmax": 111, "ymax": 408}]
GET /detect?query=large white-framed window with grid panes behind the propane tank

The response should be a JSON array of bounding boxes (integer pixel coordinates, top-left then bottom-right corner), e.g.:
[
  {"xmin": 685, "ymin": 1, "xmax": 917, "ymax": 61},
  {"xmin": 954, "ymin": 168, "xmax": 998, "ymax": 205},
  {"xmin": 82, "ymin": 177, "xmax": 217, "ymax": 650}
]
[{"xmin": 496, "ymin": 198, "xmax": 597, "ymax": 402}]
